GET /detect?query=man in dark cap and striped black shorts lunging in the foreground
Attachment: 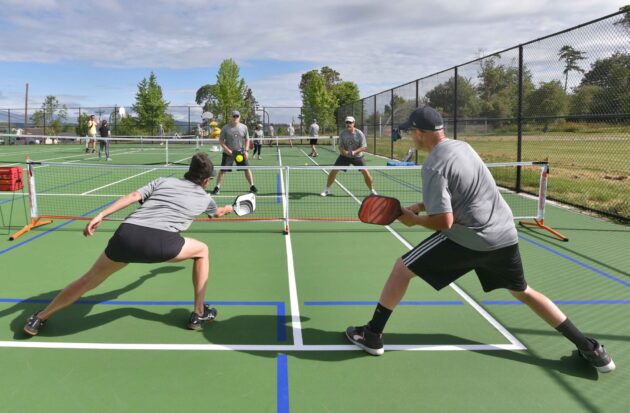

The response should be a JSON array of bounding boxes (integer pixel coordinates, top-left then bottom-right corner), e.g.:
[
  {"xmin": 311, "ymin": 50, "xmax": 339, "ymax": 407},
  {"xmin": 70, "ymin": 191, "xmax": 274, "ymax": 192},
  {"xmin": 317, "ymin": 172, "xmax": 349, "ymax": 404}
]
[{"xmin": 346, "ymin": 107, "xmax": 615, "ymax": 373}]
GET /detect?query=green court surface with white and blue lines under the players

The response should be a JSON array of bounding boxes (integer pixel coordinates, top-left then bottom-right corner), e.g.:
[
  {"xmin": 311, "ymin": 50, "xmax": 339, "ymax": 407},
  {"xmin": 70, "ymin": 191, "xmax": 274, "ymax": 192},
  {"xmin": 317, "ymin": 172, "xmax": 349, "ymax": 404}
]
[{"xmin": 0, "ymin": 142, "xmax": 630, "ymax": 413}]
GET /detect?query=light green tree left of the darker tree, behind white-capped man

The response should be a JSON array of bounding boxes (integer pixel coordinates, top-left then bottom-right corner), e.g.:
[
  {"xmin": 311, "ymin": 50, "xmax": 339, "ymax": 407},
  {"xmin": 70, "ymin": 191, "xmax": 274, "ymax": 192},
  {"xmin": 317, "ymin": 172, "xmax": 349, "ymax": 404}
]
[{"xmin": 300, "ymin": 70, "xmax": 337, "ymax": 129}]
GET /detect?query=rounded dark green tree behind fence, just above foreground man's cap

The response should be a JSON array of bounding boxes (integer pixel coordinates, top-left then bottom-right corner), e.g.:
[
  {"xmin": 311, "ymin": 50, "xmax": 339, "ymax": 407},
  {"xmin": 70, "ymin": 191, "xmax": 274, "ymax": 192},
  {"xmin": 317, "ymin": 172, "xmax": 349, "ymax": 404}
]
[{"xmin": 426, "ymin": 76, "xmax": 481, "ymax": 117}]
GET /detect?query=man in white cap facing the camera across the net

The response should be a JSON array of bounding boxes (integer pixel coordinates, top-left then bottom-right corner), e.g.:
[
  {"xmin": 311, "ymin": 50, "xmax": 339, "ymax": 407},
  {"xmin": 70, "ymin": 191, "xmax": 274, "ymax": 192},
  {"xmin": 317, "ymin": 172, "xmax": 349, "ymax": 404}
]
[{"xmin": 320, "ymin": 116, "xmax": 376, "ymax": 196}]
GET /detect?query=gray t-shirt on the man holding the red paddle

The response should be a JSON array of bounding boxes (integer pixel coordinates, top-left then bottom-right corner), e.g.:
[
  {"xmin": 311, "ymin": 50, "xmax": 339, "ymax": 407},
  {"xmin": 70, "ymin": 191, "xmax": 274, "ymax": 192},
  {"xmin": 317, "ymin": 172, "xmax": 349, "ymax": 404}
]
[{"xmin": 422, "ymin": 139, "xmax": 518, "ymax": 251}]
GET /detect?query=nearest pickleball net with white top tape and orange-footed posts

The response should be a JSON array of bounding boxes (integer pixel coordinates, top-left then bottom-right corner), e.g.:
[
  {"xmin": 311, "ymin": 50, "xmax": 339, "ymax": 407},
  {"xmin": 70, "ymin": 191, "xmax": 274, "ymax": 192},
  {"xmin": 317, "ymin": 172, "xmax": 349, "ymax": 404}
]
[{"xmin": 12, "ymin": 161, "xmax": 568, "ymax": 239}]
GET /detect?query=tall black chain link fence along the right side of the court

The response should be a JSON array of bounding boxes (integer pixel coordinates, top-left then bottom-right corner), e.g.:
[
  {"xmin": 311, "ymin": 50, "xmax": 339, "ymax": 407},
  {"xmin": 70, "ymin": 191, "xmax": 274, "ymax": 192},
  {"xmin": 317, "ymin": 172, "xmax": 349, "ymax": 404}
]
[{"xmin": 337, "ymin": 8, "xmax": 630, "ymax": 222}]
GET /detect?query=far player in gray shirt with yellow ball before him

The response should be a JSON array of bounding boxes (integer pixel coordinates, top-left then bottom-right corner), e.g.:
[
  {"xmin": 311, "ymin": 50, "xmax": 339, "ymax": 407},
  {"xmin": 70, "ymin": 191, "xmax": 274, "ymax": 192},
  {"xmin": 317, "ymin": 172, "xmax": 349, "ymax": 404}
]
[{"xmin": 212, "ymin": 110, "xmax": 258, "ymax": 195}]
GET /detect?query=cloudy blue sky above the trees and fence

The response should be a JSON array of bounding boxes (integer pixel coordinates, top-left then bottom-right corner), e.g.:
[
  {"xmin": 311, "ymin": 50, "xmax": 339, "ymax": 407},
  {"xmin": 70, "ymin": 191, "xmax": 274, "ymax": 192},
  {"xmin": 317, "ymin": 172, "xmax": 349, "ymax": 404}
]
[{"xmin": 0, "ymin": 0, "xmax": 624, "ymax": 109}]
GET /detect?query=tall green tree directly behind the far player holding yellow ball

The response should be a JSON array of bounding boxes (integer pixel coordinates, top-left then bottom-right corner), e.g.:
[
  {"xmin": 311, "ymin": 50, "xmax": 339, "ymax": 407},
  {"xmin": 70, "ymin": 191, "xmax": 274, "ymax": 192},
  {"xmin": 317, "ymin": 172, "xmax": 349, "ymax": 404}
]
[{"xmin": 195, "ymin": 59, "xmax": 256, "ymax": 122}]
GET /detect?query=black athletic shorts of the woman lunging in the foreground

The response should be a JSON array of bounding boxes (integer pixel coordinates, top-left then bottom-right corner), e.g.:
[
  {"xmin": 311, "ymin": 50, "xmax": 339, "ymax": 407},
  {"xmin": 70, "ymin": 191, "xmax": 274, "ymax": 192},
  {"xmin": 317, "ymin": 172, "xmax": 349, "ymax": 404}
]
[{"xmin": 105, "ymin": 224, "xmax": 185, "ymax": 263}]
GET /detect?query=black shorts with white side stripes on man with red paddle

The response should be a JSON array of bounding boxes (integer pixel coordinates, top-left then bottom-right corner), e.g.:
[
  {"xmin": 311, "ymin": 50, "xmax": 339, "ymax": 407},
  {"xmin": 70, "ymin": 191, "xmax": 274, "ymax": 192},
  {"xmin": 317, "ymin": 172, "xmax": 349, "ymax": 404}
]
[{"xmin": 402, "ymin": 232, "xmax": 527, "ymax": 292}]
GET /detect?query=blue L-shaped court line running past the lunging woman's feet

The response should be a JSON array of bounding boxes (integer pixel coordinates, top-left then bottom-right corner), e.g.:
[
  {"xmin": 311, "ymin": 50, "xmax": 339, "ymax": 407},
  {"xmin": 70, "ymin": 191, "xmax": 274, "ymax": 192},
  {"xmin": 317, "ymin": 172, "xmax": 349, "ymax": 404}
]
[{"xmin": 0, "ymin": 298, "xmax": 287, "ymax": 341}]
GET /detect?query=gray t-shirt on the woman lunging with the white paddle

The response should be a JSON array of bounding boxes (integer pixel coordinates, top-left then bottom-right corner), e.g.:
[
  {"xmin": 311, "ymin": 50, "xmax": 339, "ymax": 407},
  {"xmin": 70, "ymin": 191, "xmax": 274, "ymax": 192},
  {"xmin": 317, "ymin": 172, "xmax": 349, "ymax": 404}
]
[{"xmin": 124, "ymin": 178, "xmax": 217, "ymax": 232}]
